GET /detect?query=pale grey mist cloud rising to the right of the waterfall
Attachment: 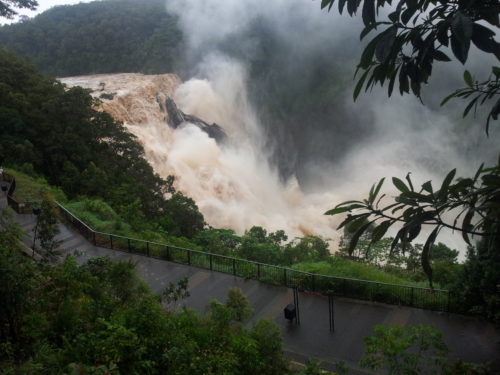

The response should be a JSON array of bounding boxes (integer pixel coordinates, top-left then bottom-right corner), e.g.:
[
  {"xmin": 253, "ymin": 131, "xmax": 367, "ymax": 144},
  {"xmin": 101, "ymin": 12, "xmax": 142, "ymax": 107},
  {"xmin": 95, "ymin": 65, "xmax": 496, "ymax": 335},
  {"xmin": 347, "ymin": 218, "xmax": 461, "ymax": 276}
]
[{"xmin": 163, "ymin": 0, "xmax": 500, "ymax": 254}]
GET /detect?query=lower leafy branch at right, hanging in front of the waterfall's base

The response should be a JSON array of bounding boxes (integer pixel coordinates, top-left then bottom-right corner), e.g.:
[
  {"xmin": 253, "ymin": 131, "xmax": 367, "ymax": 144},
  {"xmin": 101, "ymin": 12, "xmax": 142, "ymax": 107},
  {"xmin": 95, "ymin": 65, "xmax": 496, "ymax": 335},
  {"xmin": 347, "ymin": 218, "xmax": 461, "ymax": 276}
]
[{"xmin": 326, "ymin": 160, "xmax": 500, "ymax": 292}]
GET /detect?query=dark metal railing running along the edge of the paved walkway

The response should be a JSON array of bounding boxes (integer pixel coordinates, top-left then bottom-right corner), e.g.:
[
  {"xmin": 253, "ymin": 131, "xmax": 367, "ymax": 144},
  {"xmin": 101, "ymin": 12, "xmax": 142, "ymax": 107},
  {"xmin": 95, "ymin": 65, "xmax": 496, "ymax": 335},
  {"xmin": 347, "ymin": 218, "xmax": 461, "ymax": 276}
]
[{"xmin": 56, "ymin": 201, "xmax": 451, "ymax": 312}]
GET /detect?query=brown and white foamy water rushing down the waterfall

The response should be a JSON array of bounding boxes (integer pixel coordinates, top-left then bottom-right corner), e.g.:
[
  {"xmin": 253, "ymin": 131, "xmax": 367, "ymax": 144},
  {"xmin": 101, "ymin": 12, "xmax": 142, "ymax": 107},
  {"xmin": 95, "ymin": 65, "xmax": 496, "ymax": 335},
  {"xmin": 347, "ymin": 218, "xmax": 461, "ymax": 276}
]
[{"xmin": 61, "ymin": 63, "xmax": 338, "ymax": 242}]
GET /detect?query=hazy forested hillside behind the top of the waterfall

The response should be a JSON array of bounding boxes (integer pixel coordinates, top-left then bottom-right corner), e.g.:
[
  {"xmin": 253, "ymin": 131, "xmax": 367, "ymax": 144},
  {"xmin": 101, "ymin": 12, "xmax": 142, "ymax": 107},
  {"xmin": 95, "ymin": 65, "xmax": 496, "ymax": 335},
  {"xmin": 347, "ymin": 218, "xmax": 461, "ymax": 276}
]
[{"xmin": 0, "ymin": 0, "xmax": 183, "ymax": 77}]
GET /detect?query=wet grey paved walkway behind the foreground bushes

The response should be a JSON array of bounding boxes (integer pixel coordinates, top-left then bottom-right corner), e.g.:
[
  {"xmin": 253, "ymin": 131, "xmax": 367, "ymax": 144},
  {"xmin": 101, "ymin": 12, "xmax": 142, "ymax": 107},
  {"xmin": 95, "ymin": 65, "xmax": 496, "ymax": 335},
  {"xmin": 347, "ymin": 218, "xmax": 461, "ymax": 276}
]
[{"xmin": 7, "ymin": 204, "xmax": 500, "ymax": 374}]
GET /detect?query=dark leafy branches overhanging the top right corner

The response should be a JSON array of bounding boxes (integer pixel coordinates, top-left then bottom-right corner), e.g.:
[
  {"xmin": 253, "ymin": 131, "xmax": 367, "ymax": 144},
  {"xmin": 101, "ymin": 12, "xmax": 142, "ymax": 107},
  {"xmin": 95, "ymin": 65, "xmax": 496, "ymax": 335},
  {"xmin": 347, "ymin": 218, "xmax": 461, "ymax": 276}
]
[{"xmin": 321, "ymin": 0, "xmax": 500, "ymax": 133}]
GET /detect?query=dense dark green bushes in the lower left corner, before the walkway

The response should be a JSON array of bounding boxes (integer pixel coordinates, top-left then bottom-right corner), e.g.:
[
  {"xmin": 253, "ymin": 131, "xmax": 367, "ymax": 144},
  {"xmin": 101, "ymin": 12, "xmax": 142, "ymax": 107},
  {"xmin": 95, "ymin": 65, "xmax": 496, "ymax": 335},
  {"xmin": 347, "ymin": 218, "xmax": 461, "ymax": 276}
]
[{"xmin": 0, "ymin": 216, "xmax": 288, "ymax": 374}]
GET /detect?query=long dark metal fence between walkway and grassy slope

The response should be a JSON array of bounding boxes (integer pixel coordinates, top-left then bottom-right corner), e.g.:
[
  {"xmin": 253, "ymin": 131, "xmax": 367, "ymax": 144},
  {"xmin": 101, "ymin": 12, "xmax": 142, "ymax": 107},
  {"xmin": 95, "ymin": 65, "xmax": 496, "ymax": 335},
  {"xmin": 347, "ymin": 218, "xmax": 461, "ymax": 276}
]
[{"xmin": 57, "ymin": 203, "xmax": 459, "ymax": 312}]
